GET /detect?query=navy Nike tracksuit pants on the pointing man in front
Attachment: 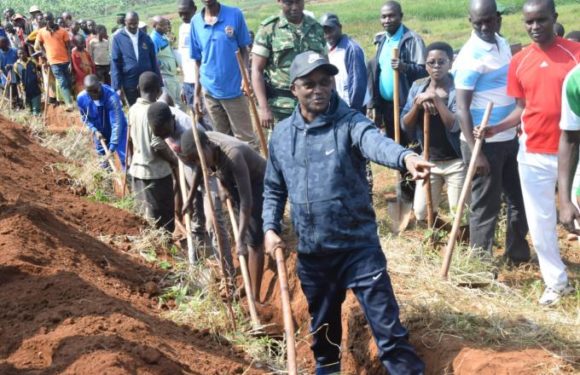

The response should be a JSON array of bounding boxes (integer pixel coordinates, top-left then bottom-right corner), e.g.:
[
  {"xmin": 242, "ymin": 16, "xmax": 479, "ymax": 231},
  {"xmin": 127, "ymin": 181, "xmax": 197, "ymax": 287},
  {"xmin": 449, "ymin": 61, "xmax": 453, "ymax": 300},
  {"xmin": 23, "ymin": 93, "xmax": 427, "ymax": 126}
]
[{"xmin": 298, "ymin": 248, "xmax": 425, "ymax": 375}]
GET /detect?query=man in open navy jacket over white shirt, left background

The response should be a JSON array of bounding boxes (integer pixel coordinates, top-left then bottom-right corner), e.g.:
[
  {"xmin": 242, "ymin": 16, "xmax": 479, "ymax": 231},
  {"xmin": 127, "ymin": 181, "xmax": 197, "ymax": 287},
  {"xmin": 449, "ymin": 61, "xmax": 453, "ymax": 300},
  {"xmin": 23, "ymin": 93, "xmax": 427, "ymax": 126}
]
[{"xmin": 111, "ymin": 12, "xmax": 161, "ymax": 106}]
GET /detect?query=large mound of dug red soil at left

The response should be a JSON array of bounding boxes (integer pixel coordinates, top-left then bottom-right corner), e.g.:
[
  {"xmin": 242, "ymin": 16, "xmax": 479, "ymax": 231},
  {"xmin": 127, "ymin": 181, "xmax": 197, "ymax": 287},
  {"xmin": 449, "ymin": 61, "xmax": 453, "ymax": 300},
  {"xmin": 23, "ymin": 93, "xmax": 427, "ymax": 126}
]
[{"xmin": 0, "ymin": 118, "xmax": 259, "ymax": 374}]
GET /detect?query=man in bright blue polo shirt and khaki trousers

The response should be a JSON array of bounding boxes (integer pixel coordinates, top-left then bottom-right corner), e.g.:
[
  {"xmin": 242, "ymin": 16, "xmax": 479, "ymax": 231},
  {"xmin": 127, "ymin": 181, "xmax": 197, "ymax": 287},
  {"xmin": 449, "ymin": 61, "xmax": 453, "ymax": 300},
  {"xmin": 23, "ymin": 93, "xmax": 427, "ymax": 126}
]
[{"xmin": 190, "ymin": 0, "xmax": 258, "ymax": 149}]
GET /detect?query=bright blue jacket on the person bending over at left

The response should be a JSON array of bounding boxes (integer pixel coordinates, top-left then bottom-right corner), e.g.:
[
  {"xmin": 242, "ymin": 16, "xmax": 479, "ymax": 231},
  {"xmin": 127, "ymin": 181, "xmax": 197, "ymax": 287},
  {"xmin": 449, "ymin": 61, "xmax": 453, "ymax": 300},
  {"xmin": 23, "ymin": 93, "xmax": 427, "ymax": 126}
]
[{"xmin": 77, "ymin": 85, "xmax": 127, "ymax": 153}]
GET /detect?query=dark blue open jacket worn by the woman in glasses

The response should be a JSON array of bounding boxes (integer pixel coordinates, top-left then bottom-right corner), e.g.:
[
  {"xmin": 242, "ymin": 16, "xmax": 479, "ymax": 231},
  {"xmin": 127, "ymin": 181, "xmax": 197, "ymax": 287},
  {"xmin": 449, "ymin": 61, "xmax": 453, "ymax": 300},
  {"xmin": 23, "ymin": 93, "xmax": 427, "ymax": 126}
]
[{"xmin": 401, "ymin": 78, "xmax": 461, "ymax": 156}]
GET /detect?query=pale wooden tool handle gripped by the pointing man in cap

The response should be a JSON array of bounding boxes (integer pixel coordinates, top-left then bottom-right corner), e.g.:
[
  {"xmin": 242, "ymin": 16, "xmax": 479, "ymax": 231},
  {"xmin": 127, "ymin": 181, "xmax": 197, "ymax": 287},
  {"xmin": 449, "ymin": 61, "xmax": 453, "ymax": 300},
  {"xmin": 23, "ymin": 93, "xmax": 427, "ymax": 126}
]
[{"xmin": 275, "ymin": 247, "xmax": 298, "ymax": 375}]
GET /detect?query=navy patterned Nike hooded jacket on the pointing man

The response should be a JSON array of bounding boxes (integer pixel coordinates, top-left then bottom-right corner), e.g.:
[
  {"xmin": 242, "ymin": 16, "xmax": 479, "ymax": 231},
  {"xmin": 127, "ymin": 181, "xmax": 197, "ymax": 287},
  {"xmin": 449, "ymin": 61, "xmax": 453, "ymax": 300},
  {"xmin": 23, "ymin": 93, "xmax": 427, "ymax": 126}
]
[{"xmin": 262, "ymin": 94, "xmax": 410, "ymax": 254}]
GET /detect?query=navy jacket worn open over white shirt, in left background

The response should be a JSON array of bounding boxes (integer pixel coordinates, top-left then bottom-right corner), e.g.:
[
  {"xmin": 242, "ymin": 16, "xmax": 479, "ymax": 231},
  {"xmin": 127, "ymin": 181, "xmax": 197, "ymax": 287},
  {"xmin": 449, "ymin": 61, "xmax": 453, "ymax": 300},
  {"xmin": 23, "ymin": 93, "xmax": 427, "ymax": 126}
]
[{"xmin": 111, "ymin": 28, "xmax": 161, "ymax": 90}]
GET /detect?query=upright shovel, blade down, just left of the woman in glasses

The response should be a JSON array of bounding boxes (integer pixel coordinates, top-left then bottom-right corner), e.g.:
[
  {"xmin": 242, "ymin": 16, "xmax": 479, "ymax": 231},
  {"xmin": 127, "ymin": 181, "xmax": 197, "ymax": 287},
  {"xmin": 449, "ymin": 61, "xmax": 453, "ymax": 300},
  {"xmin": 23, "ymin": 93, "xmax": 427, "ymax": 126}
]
[{"xmin": 387, "ymin": 47, "xmax": 414, "ymax": 234}]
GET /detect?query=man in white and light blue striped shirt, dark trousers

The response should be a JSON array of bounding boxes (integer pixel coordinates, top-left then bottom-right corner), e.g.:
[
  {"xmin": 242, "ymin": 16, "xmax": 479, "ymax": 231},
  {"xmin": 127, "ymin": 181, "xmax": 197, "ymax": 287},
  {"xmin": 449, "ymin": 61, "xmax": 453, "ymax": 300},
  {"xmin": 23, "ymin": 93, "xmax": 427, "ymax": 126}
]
[{"xmin": 453, "ymin": 0, "xmax": 530, "ymax": 264}]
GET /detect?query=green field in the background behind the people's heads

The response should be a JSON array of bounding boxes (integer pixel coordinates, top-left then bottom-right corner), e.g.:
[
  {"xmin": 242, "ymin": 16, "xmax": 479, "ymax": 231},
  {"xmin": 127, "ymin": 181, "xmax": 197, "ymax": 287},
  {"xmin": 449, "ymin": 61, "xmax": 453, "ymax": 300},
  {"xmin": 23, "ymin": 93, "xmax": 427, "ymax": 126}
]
[{"xmin": 97, "ymin": 0, "xmax": 580, "ymax": 55}]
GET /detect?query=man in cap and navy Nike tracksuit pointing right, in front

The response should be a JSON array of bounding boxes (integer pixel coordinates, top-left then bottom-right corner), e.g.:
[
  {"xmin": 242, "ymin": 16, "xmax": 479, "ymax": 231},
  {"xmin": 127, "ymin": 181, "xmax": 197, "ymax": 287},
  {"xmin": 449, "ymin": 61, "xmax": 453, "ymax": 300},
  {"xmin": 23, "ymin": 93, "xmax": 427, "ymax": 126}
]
[{"xmin": 262, "ymin": 51, "xmax": 432, "ymax": 374}]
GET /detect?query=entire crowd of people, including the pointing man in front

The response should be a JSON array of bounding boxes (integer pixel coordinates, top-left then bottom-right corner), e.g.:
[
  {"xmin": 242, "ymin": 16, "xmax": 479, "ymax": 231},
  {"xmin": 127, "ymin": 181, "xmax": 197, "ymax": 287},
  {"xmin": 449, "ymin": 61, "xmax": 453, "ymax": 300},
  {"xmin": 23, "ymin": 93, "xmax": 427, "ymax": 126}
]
[{"xmin": 0, "ymin": 0, "xmax": 580, "ymax": 374}]
